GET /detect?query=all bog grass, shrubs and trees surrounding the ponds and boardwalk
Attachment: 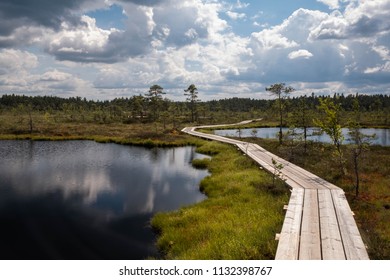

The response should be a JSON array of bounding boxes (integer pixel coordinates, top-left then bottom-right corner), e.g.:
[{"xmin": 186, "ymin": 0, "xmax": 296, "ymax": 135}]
[{"xmin": 0, "ymin": 88, "xmax": 390, "ymax": 259}]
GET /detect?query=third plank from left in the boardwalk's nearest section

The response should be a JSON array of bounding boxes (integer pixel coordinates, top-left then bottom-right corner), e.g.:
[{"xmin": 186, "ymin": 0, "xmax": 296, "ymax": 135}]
[{"xmin": 318, "ymin": 189, "xmax": 345, "ymax": 260}]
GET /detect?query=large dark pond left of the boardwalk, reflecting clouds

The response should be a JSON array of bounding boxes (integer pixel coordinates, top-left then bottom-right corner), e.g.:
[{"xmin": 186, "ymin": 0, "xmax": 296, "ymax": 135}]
[{"xmin": 0, "ymin": 141, "xmax": 207, "ymax": 259}]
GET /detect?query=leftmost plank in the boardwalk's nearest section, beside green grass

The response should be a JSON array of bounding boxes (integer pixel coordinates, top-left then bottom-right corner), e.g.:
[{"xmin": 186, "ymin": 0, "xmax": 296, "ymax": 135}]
[{"xmin": 275, "ymin": 188, "xmax": 304, "ymax": 260}]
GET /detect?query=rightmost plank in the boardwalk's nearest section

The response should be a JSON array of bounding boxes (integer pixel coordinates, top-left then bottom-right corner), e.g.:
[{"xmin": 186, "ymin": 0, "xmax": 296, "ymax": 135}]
[{"xmin": 331, "ymin": 190, "xmax": 369, "ymax": 260}]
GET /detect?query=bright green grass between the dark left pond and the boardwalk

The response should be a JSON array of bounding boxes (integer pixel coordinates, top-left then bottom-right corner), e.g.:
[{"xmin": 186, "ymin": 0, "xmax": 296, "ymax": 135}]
[{"xmin": 152, "ymin": 142, "xmax": 289, "ymax": 259}]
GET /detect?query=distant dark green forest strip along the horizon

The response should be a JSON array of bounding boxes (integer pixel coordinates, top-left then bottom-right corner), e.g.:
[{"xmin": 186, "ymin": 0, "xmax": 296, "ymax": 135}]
[{"xmin": 0, "ymin": 93, "xmax": 390, "ymax": 112}]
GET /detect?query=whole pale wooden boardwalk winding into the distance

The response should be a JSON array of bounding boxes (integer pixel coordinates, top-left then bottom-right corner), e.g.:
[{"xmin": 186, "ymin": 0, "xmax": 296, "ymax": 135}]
[{"xmin": 182, "ymin": 121, "xmax": 369, "ymax": 260}]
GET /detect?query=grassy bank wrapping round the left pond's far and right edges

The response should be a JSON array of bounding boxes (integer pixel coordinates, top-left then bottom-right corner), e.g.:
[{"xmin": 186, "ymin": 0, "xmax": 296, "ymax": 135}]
[{"xmin": 0, "ymin": 126, "xmax": 289, "ymax": 259}]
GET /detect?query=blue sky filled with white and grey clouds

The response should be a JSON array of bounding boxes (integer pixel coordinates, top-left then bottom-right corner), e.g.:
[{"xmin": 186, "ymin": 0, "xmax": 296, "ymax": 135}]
[{"xmin": 0, "ymin": 0, "xmax": 390, "ymax": 101}]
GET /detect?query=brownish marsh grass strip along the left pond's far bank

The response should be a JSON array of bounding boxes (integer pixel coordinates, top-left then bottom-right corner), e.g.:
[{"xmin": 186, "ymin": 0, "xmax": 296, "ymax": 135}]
[{"xmin": 0, "ymin": 114, "xmax": 207, "ymax": 148}]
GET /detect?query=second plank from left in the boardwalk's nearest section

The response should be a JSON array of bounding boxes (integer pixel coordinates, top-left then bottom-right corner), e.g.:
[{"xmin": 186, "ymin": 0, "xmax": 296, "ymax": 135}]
[{"xmin": 299, "ymin": 189, "xmax": 322, "ymax": 260}]
